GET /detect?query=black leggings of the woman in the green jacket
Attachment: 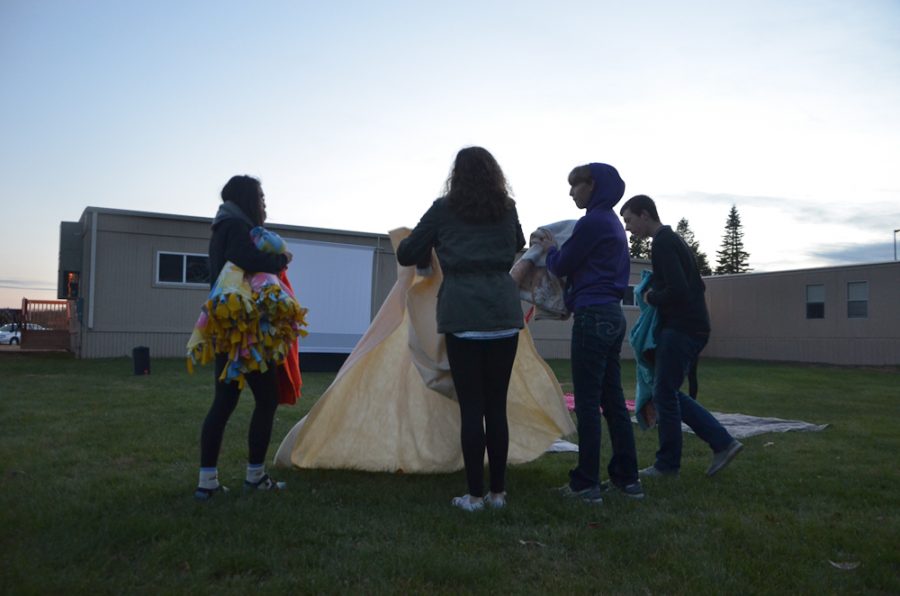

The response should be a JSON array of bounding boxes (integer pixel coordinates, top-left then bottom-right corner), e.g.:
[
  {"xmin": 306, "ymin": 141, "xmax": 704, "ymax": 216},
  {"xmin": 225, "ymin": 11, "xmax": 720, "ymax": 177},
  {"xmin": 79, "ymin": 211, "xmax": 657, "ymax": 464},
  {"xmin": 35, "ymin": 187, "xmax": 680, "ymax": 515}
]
[{"xmin": 446, "ymin": 333, "xmax": 519, "ymax": 497}]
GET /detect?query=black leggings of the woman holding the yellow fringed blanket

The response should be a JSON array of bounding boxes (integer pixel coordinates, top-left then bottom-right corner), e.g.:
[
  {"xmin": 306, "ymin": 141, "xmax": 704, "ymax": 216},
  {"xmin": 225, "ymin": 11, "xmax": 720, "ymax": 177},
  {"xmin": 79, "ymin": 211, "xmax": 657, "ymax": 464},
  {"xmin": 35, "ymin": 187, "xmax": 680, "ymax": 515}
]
[{"xmin": 200, "ymin": 354, "xmax": 278, "ymax": 468}]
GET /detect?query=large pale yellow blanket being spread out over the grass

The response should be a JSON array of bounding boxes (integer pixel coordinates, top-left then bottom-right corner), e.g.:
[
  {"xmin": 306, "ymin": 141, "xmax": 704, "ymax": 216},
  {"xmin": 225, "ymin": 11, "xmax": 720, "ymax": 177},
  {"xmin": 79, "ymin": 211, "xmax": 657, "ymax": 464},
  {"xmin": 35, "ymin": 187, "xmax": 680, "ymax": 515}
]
[{"xmin": 275, "ymin": 228, "xmax": 575, "ymax": 473}]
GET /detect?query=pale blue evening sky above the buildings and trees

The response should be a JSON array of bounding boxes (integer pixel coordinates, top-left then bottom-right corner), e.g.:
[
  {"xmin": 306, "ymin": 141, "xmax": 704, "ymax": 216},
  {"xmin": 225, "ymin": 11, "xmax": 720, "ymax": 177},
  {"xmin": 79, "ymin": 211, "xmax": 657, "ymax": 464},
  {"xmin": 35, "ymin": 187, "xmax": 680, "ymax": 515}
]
[{"xmin": 0, "ymin": 0, "xmax": 900, "ymax": 307}]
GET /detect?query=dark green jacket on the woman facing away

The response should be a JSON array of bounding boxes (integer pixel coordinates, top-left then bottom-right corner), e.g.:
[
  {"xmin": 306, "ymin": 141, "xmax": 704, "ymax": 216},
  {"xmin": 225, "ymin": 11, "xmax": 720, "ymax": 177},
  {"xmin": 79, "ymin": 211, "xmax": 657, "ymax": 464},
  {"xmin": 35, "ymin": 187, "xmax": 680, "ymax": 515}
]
[{"xmin": 397, "ymin": 198, "xmax": 525, "ymax": 333}]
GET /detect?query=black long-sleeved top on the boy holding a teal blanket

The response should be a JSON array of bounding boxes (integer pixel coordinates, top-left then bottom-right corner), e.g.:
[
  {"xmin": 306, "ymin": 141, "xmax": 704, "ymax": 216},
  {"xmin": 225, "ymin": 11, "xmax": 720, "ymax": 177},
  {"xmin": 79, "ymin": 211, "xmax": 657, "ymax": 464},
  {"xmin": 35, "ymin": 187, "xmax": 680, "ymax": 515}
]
[{"xmin": 645, "ymin": 226, "xmax": 710, "ymax": 335}]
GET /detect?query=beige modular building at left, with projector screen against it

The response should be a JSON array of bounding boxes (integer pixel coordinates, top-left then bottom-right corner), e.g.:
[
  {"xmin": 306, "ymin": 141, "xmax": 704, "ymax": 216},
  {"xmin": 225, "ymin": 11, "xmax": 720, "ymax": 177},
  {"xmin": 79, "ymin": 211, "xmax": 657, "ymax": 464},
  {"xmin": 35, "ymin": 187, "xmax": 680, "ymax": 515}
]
[{"xmin": 58, "ymin": 207, "xmax": 396, "ymax": 364}]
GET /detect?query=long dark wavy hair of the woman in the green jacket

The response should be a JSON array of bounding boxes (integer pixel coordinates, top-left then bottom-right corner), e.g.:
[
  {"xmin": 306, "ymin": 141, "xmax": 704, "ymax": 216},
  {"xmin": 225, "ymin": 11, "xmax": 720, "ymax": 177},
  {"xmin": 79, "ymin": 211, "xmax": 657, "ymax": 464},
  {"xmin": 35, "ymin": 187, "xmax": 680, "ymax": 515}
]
[{"xmin": 444, "ymin": 147, "xmax": 516, "ymax": 222}]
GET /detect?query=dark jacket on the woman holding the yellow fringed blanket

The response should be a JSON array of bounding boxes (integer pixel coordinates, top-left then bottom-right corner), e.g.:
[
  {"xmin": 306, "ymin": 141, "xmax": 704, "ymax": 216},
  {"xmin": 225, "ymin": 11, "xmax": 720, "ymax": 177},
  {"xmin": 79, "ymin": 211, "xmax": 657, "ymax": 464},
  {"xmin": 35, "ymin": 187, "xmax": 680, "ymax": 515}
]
[{"xmin": 209, "ymin": 203, "xmax": 287, "ymax": 287}]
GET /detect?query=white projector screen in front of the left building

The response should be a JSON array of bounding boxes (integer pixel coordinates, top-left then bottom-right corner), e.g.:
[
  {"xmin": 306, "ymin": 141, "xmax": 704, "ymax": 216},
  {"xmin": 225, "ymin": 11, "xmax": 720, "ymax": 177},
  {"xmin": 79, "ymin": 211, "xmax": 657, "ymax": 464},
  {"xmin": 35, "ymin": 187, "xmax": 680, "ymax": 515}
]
[{"xmin": 286, "ymin": 239, "xmax": 375, "ymax": 354}]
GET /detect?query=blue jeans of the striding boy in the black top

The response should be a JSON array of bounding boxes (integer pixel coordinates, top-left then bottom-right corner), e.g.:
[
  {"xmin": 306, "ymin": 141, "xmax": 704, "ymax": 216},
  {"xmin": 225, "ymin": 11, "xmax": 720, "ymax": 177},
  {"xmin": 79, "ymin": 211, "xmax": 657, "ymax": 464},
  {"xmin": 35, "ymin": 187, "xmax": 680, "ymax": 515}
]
[{"xmin": 653, "ymin": 327, "xmax": 734, "ymax": 472}]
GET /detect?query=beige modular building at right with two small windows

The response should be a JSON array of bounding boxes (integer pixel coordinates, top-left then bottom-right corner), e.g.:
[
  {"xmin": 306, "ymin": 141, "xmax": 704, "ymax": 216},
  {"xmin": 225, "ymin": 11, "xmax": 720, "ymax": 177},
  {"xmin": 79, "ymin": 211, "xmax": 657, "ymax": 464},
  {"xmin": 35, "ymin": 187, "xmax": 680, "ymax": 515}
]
[{"xmin": 704, "ymin": 261, "xmax": 900, "ymax": 366}]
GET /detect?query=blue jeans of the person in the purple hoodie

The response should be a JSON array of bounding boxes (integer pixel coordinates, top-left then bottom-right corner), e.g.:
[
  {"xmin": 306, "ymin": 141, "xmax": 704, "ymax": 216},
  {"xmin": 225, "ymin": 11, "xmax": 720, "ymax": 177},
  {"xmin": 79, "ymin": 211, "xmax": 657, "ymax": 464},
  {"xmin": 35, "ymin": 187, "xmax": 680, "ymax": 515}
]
[{"xmin": 569, "ymin": 302, "xmax": 638, "ymax": 490}]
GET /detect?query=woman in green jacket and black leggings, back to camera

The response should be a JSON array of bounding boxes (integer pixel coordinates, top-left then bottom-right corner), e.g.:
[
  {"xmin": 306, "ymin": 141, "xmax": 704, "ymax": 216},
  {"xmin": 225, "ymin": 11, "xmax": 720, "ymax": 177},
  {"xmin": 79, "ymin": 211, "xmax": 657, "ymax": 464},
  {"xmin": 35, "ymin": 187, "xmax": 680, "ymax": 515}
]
[{"xmin": 397, "ymin": 147, "xmax": 525, "ymax": 511}]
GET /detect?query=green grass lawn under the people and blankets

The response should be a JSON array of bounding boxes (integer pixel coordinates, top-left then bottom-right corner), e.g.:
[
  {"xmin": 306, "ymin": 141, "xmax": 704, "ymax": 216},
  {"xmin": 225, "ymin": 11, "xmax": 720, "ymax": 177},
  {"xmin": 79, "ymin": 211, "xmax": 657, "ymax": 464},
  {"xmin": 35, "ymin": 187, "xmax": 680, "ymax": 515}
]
[{"xmin": 0, "ymin": 354, "xmax": 900, "ymax": 594}]
